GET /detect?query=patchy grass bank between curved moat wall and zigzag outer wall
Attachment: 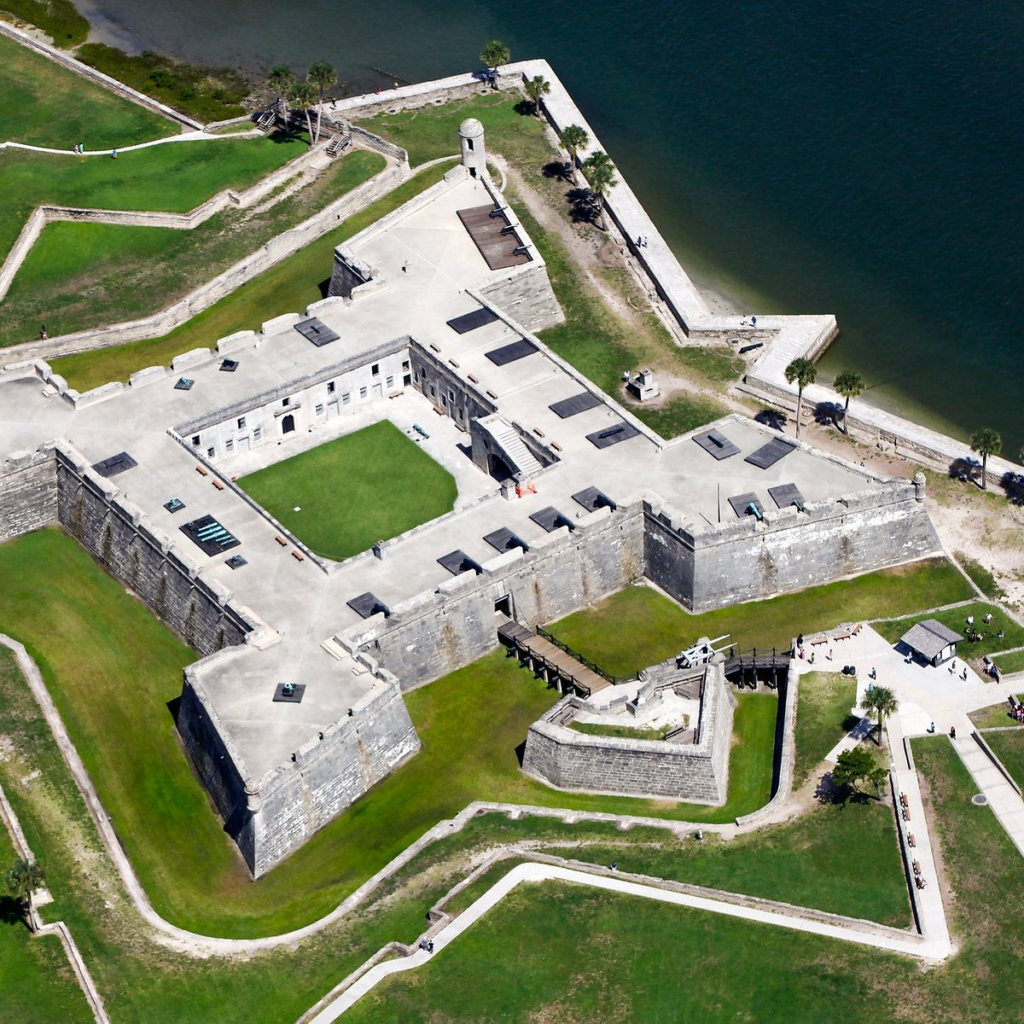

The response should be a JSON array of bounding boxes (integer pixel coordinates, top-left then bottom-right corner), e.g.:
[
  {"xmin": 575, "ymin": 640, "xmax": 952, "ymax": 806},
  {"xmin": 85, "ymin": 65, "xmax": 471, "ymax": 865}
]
[{"xmin": 0, "ymin": 651, "xmax": 905, "ymax": 1024}]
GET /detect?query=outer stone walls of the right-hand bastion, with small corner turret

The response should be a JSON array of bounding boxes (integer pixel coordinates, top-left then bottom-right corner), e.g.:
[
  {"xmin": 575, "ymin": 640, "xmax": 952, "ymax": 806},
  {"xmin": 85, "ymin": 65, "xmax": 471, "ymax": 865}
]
[{"xmin": 644, "ymin": 480, "xmax": 942, "ymax": 611}]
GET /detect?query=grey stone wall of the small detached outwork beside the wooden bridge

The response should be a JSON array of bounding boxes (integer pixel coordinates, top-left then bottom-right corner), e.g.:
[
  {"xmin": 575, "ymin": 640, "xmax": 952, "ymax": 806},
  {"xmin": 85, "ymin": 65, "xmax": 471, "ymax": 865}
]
[{"xmin": 522, "ymin": 665, "xmax": 733, "ymax": 804}]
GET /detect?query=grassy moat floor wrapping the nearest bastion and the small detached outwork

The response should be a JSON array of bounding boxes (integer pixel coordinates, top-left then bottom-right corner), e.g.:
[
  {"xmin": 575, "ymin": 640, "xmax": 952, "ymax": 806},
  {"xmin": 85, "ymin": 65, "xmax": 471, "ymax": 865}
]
[{"xmin": 0, "ymin": 529, "xmax": 777, "ymax": 936}]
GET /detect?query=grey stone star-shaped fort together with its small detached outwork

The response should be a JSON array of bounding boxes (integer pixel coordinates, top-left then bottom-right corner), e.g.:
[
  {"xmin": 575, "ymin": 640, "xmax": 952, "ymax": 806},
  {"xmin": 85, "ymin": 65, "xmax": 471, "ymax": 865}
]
[{"xmin": 0, "ymin": 121, "xmax": 940, "ymax": 877}]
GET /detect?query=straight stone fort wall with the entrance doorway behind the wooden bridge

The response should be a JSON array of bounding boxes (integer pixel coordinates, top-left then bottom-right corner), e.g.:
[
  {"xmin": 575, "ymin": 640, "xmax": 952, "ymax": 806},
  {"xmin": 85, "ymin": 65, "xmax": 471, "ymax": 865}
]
[{"xmin": 345, "ymin": 498, "xmax": 643, "ymax": 688}]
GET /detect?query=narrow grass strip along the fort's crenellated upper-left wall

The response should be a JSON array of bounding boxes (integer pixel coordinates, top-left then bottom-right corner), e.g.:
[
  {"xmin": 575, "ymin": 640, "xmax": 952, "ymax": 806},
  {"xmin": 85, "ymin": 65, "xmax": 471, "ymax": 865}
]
[{"xmin": 52, "ymin": 159, "xmax": 452, "ymax": 391}]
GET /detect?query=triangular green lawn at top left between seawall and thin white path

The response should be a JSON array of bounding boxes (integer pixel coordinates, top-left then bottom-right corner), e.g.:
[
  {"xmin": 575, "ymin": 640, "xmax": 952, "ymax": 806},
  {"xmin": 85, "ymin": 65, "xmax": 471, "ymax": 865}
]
[{"xmin": 0, "ymin": 30, "xmax": 169, "ymax": 146}]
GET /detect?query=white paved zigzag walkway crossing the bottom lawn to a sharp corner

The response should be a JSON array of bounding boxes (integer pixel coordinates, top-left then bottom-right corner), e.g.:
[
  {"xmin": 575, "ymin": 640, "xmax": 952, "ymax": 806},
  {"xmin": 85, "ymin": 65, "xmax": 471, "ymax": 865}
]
[{"xmin": 309, "ymin": 863, "xmax": 952, "ymax": 1024}]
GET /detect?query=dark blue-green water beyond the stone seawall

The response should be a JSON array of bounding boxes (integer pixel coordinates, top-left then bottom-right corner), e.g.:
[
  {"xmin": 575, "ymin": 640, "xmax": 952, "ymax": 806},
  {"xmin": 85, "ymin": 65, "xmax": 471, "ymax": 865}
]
[{"xmin": 77, "ymin": 0, "xmax": 1024, "ymax": 458}]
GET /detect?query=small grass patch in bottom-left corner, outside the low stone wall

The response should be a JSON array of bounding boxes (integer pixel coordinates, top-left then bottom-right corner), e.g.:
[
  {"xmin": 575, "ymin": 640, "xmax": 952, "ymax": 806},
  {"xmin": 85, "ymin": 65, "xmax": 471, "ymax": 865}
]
[{"xmin": 0, "ymin": 802, "xmax": 92, "ymax": 1024}]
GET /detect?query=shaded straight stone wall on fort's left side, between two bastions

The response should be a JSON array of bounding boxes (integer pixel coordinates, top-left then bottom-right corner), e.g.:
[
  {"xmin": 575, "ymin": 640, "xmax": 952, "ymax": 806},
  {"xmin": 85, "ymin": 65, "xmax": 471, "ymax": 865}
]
[{"xmin": 56, "ymin": 444, "xmax": 258, "ymax": 654}]
